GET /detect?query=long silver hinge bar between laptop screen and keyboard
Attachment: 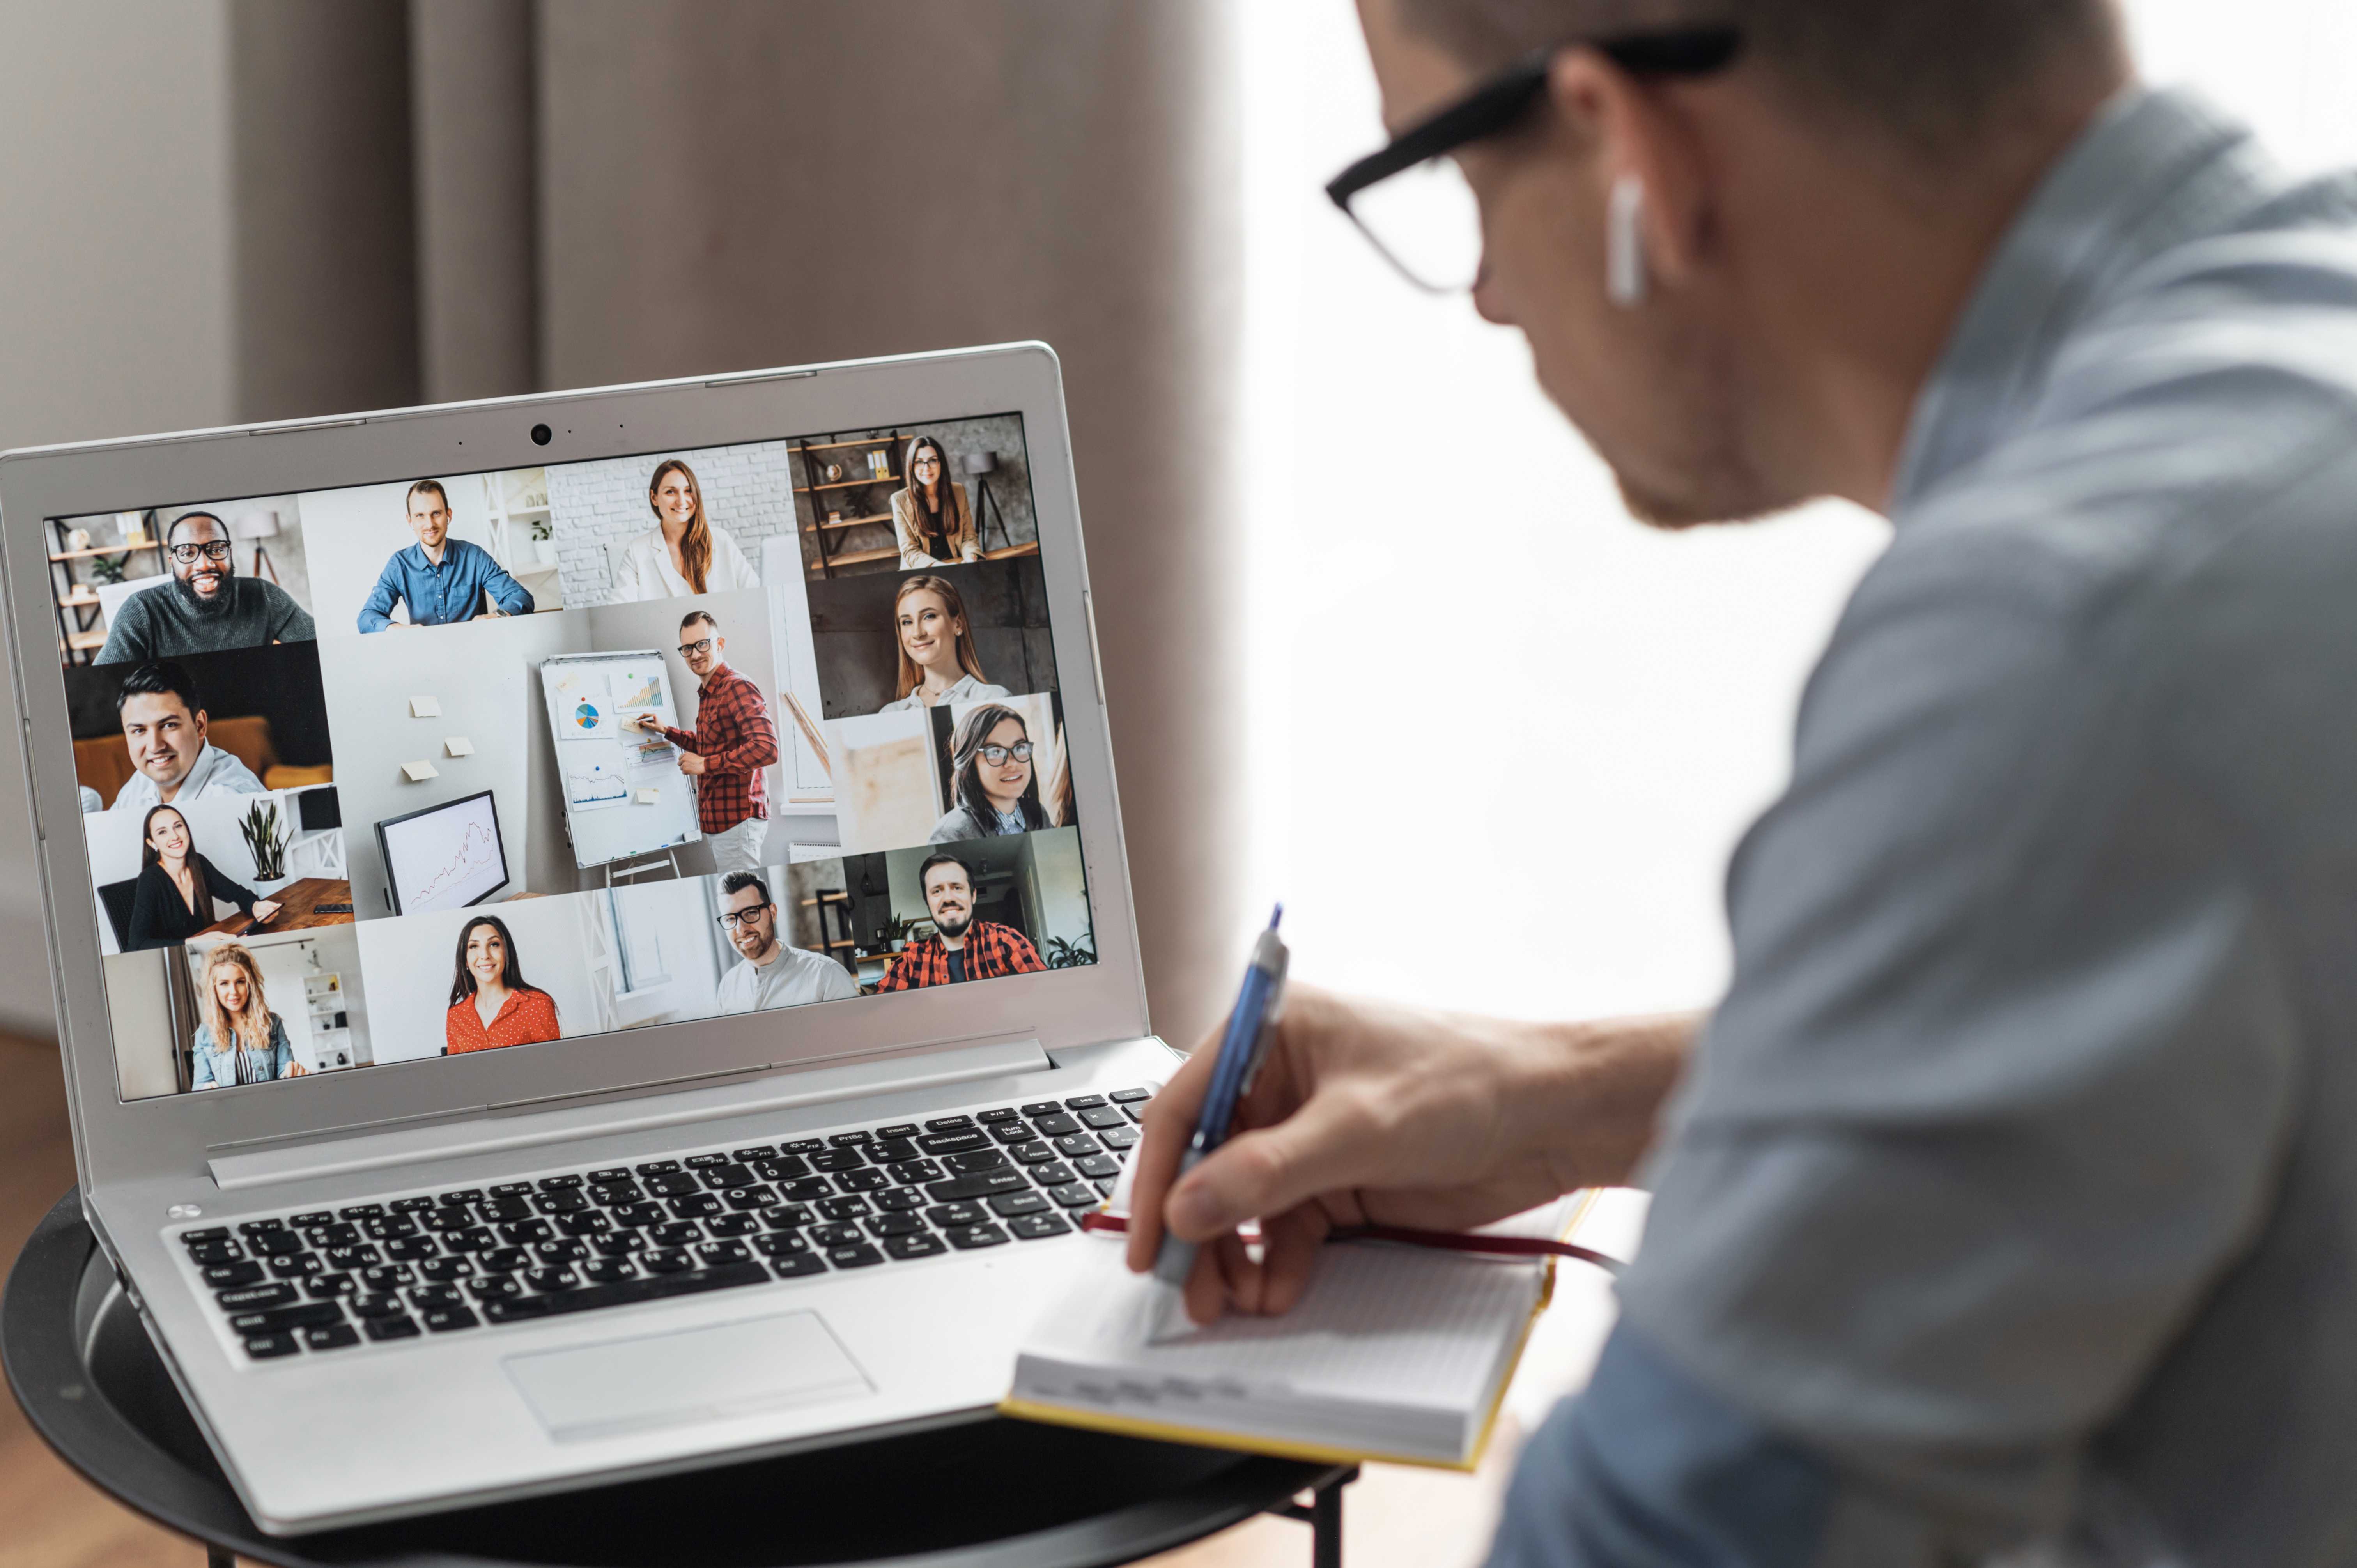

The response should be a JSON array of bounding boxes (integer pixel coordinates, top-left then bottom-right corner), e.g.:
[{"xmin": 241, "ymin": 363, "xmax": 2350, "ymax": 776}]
[{"xmin": 207, "ymin": 1037, "xmax": 1056, "ymax": 1191}]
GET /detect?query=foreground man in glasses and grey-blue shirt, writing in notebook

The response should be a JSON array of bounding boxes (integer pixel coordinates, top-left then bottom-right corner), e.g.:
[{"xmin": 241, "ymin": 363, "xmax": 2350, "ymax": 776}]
[{"xmin": 1129, "ymin": 0, "xmax": 2357, "ymax": 1568}]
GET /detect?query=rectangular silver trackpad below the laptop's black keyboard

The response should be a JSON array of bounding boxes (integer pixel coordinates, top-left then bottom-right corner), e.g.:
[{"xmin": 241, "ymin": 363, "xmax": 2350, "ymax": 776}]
[{"xmin": 502, "ymin": 1311, "xmax": 875, "ymax": 1443}]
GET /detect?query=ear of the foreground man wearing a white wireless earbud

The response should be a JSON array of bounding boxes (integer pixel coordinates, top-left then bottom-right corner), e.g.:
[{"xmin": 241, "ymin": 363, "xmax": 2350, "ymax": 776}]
[{"xmin": 1546, "ymin": 50, "xmax": 1711, "ymax": 285}]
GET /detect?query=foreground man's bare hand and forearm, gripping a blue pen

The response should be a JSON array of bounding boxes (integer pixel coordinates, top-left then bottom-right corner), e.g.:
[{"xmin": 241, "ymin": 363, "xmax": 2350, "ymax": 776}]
[{"xmin": 1129, "ymin": 986, "xmax": 1699, "ymax": 1323}]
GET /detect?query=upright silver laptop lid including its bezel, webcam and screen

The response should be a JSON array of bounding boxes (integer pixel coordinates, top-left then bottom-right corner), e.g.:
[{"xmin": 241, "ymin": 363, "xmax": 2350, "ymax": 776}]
[{"xmin": 0, "ymin": 344, "xmax": 1148, "ymax": 1188}]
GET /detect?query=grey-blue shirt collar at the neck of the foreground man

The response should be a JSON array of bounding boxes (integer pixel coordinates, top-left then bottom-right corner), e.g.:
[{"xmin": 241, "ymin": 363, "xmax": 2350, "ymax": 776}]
[{"xmin": 1890, "ymin": 87, "xmax": 2282, "ymax": 521}]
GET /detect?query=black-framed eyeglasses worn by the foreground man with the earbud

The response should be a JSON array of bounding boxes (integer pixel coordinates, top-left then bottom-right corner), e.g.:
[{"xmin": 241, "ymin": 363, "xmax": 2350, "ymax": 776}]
[{"xmin": 1327, "ymin": 26, "xmax": 1744, "ymax": 295}]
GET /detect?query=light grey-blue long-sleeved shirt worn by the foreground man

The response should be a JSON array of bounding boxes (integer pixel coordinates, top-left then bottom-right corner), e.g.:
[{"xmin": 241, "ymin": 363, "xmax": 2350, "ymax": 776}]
[{"xmin": 1492, "ymin": 94, "xmax": 2357, "ymax": 1568}]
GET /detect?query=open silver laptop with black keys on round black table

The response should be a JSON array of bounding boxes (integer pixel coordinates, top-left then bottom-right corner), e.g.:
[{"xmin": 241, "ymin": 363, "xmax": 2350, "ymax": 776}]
[{"xmin": 0, "ymin": 344, "xmax": 1176, "ymax": 1533}]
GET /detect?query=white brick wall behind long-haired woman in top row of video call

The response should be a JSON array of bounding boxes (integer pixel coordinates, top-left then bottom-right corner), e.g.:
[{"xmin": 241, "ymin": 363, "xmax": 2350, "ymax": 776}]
[{"xmin": 549, "ymin": 441, "xmax": 794, "ymax": 606}]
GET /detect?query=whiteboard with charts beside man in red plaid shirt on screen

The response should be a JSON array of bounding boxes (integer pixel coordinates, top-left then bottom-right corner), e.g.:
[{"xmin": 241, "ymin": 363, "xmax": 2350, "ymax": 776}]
[{"xmin": 540, "ymin": 648, "xmax": 702, "ymax": 870}]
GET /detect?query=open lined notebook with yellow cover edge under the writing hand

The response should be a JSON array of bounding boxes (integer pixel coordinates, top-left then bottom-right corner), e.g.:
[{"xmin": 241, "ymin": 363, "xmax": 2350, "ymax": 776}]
[{"xmin": 999, "ymin": 1193, "xmax": 1593, "ymax": 1469}]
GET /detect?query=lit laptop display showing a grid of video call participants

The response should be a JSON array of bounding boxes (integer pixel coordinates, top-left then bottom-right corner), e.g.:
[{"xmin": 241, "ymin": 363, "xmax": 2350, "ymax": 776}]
[{"xmin": 35, "ymin": 415, "xmax": 1096, "ymax": 1099}]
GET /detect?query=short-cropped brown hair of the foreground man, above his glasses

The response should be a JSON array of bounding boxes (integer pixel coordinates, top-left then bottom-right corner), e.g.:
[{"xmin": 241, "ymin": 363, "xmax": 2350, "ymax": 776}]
[{"xmin": 1395, "ymin": 0, "xmax": 2124, "ymax": 160}]
